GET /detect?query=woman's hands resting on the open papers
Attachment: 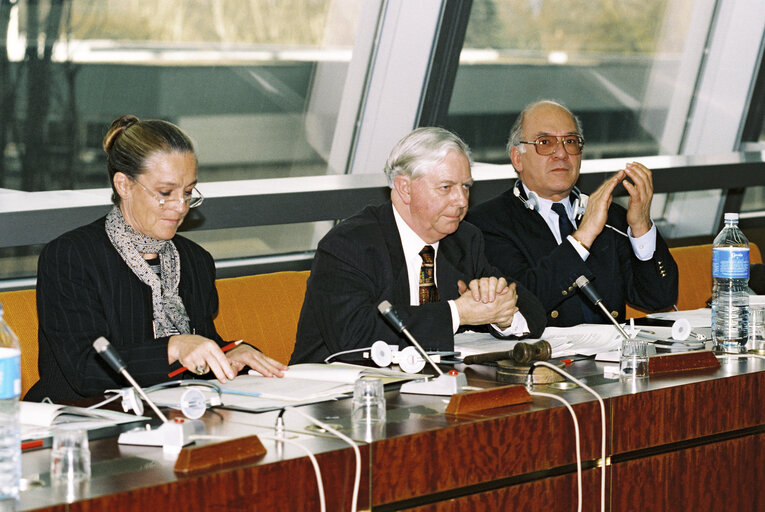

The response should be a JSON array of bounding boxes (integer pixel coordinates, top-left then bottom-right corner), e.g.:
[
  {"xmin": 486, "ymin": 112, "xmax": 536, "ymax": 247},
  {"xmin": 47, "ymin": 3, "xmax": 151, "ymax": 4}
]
[{"xmin": 167, "ymin": 334, "xmax": 287, "ymax": 382}]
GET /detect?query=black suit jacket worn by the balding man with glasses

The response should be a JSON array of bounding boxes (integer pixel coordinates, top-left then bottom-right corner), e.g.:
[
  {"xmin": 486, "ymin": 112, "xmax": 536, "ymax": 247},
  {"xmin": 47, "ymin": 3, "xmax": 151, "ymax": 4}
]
[{"xmin": 467, "ymin": 188, "xmax": 677, "ymax": 326}]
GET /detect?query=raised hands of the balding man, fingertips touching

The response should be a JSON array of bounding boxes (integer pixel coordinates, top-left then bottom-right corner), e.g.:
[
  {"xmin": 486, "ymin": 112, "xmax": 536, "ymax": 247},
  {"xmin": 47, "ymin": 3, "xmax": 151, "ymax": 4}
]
[{"xmin": 572, "ymin": 162, "xmax": 653, "ymax": 249}]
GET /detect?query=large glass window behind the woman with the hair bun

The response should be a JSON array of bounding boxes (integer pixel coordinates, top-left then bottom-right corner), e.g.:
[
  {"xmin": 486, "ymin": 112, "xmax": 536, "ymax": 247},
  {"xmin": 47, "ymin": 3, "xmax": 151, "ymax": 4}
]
[{"xmin": 0, "ymin": 0, "xmax": 376, "ymax": 278}]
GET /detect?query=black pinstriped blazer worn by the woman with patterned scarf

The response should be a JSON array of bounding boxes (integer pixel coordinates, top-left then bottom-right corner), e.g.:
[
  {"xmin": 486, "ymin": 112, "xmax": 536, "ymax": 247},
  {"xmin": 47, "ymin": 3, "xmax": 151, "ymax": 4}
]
[{"xmin": 25, "ymin": 217, "xmax": 222, "ymax": 401}]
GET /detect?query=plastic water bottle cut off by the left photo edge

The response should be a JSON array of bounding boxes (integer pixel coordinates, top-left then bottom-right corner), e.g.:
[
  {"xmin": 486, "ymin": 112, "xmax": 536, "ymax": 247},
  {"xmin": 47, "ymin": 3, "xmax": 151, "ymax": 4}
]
[{"xmin": 0, "ymin": 304, "xmax": 21, "ymax": 503}]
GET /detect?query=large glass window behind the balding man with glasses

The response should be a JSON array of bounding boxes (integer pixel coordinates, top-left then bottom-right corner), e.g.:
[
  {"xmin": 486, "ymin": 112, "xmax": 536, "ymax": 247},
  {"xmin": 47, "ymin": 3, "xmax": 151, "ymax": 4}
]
[{"xmin": 447, "ymin": 0, "xmax": 700, "ymax": 163}]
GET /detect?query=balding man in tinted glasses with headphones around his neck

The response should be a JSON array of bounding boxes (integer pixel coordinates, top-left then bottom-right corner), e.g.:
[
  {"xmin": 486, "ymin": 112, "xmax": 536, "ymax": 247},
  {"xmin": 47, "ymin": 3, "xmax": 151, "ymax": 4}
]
[{"xmin": 467, "ymin": 100, "xmax": 677, "ymax": 326}]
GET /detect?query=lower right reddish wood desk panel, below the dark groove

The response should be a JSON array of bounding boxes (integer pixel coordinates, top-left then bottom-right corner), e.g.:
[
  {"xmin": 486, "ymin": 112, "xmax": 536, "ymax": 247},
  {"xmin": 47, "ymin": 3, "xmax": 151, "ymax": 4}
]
[{"xmin": 611, "ymin": 434, "xmax": 765, "ymax": 512}]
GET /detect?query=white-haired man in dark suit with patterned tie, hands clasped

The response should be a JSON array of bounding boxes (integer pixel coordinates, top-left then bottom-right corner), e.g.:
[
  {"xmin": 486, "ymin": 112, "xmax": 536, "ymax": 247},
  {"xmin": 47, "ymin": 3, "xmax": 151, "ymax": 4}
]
[{"xmin": 290, "ymin": 128, "xmax": 544, "ymax": 364}]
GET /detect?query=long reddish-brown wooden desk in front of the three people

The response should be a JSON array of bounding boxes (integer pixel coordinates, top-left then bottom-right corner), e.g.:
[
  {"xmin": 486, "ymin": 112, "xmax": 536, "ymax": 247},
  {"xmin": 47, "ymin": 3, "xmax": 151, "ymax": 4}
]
[{"xmin": 20, "ymin": 360, "xmax": 765, "ymax": 512}]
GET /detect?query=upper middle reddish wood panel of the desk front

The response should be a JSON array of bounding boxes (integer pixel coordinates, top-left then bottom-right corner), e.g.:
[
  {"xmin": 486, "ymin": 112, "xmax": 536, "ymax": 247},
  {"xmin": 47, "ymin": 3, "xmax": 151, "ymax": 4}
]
[{"xmin": 372, "ymin": 398, "xmax": 601, "ymax": 506}]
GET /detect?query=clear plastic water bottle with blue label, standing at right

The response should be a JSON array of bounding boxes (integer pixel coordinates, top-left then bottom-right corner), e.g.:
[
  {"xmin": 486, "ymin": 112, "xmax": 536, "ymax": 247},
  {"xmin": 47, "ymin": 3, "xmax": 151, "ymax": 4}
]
[{"xmin": 712, "ymin": 213, "xmax": 749, "ymax": 353}]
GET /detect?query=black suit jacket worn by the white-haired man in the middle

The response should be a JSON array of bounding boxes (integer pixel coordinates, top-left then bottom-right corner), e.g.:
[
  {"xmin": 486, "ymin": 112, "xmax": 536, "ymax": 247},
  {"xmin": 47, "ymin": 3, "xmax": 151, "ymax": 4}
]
[{"xmin": 290, "ymin": 202, "xmax": 544, "ymax": 364}]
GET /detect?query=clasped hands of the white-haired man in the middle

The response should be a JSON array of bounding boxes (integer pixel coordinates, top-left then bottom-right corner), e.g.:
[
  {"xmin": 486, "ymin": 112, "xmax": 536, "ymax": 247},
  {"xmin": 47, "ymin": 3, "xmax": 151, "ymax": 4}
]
[{"xmin": 454, "ymin": 277, "xmax": 518, "ymax": 329}]
